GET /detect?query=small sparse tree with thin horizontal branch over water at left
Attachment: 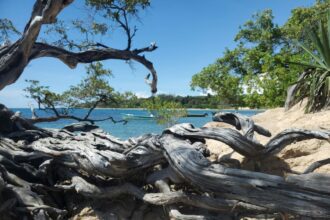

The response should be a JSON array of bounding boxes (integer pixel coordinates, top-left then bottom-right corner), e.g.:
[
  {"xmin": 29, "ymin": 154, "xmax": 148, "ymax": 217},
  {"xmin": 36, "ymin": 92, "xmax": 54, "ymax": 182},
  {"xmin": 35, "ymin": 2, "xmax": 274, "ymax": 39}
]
[{"xmin": 25, "ymin": 62, "xmax": 124, "ymax": 123}]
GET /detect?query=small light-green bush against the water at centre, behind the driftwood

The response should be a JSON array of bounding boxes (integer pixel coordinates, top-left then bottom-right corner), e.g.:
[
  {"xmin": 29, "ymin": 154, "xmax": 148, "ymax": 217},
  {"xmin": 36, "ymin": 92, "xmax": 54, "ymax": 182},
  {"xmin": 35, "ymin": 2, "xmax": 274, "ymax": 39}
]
[{"xmin": 144, "ymin": 97, "xmax": 187, "ymax": 127}]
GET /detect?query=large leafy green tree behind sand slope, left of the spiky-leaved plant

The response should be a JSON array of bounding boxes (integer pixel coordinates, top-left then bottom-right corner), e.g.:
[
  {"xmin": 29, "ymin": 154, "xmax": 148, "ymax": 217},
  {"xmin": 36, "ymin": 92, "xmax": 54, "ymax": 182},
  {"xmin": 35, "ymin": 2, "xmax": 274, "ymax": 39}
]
[{"xmin": 191, "ymin": 10, "xmax": 285, "ymax": 108}]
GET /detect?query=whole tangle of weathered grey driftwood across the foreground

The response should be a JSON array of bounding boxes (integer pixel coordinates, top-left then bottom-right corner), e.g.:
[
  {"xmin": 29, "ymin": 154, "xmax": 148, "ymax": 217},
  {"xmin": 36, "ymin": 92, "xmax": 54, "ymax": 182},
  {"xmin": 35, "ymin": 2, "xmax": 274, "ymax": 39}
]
[{"xmin": 0, "ymin": 107, "xmax": 330, "ymax": 219}]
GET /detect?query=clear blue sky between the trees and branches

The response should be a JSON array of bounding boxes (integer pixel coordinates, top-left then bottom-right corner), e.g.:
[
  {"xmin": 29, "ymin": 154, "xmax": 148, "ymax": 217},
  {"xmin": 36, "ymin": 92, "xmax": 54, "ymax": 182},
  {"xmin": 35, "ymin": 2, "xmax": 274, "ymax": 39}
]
[{"xmin": 0, "ymin": 0, "xmax": 314, "ymax": 107}]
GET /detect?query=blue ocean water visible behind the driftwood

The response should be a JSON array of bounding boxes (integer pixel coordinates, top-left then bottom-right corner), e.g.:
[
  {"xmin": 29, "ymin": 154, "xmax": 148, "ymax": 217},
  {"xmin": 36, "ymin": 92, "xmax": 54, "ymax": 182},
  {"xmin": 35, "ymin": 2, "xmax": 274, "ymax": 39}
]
[{"xmin": 12, "ymin": 108, "xmax": 262, "ymax": 139}]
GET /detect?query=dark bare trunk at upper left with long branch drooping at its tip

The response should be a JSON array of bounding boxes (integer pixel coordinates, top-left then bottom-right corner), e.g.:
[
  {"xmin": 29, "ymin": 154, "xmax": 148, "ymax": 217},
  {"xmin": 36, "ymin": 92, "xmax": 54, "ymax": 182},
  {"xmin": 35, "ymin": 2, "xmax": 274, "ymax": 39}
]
[{"xmin": 0, "ymin": 0, "xmax": 157, "ymax": 93}]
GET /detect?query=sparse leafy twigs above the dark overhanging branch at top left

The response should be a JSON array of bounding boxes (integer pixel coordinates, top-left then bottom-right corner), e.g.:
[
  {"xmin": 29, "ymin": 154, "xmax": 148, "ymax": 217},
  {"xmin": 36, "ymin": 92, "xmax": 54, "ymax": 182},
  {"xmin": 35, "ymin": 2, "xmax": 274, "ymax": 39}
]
[{"xmin": 41, "ymin": 0, "xmax": 150, "ymax": 51}]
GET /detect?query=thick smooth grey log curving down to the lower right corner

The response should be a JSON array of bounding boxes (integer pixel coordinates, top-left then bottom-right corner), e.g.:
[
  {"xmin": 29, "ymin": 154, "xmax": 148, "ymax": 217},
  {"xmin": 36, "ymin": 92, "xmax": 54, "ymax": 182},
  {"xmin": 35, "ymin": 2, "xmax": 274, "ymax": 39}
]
[{"xmin": 160, "ymin": 134, "xmax": 330, "ymax": 218}]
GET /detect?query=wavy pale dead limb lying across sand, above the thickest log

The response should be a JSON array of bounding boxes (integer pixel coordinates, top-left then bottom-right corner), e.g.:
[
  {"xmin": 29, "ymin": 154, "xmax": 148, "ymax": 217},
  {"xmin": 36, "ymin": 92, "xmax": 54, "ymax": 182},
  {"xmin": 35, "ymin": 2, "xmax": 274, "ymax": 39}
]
[{"xmin": 165, "ymin": 123, "xmax": 330, "ymax": 159}]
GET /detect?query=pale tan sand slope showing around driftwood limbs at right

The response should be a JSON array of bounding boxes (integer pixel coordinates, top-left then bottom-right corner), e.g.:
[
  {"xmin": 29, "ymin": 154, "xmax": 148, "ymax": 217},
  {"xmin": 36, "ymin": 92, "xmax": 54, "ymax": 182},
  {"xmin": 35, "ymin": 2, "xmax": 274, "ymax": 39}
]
[{"xmin": 205, "ymin": 104, "xmax": 330, "ymax": 175}]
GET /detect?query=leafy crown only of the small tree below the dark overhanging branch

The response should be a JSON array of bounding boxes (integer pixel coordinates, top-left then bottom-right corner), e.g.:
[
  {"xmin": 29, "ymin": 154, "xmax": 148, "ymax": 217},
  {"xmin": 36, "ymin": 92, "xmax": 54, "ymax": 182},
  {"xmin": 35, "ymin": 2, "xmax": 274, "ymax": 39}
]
[{"xmin": 24, "ymin": 62, "xmax": 114, "ymax": 114}]
